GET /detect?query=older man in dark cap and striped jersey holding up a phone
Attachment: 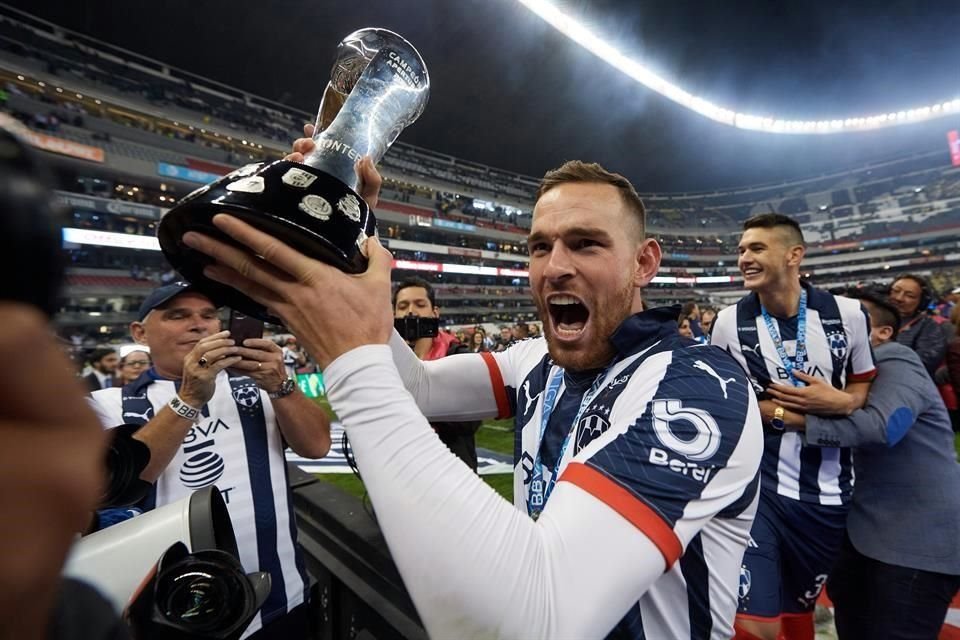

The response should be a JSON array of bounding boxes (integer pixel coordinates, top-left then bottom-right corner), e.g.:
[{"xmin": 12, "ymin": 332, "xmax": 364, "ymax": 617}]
[{"xmin": 91, "ymin": 282, "xmax": 330, "ymax": 640}]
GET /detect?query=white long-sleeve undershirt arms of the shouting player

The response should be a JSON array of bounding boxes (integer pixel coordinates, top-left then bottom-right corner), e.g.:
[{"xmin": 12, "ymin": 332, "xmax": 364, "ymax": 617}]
[{"xmin": 324, "ymin": 344, "xmax": 666, "ymax": 639}]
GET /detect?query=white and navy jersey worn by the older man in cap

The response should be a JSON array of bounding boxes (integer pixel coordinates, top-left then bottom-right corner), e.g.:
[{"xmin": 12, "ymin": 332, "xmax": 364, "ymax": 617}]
[{"xmin": 91, "ymin": 370, "xmax": 304, "ymax": 637}]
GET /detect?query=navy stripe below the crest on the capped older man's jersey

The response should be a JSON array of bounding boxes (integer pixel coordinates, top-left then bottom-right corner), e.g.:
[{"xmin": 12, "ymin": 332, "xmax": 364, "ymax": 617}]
[{"xmin": 230, "ymin": 376, "xmax": 287, "ymax": 625}]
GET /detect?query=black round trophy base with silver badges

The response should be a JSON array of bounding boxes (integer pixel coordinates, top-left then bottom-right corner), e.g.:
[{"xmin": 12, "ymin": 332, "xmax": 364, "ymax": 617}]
[{"xmin": 157, "ymin": 160, "xmax": 377, "ymax": 324}]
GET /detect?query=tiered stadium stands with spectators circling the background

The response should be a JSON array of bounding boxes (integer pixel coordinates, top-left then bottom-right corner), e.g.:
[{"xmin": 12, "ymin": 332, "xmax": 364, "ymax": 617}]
[{"xmin": 0, "ymin": 5, "xmax": 960, "ymax": 338}]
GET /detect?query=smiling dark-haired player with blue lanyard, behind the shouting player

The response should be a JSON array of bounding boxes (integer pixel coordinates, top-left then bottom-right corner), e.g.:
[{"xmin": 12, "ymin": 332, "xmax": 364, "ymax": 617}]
[{"xmin": 710, "ymin": 213, "xmax": 875, "ymax": 640}]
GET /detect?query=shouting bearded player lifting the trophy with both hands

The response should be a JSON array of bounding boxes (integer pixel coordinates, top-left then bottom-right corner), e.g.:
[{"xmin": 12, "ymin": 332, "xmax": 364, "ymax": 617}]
[{"xmin": 183, "ymin": 156, "xmax": 762, "ymax": 639}]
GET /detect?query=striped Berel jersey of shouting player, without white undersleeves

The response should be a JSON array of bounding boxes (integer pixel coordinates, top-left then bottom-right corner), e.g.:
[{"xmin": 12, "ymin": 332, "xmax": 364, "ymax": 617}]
[{"xmin": 483, "ymin": 308, "xmax": 762, "ymax": 639}]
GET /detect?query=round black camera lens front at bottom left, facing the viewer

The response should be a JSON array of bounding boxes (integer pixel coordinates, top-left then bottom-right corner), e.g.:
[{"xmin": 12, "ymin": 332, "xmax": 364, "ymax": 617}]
[{"xmin": 157, "ymin": 562, "xmax": 245, "ymax": 632}]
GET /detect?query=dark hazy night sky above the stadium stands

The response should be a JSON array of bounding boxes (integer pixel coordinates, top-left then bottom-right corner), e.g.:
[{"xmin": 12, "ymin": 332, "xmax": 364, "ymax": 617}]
[{"xmin": 9, "ymin": 0, "xmax": 960, "ymax": 192}]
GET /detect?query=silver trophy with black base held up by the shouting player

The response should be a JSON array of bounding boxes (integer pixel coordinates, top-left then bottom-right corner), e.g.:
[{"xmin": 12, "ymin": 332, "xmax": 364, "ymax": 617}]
[{"xmin": 158, "ymin": 29, "xmax": 430, "ymax": 322}]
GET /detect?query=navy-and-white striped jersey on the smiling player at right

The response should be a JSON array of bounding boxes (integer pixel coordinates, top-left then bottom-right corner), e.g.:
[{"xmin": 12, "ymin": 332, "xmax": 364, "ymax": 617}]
[{"xmin": 710, "ymin": 283, "xmax": 876, "ymax": 505}]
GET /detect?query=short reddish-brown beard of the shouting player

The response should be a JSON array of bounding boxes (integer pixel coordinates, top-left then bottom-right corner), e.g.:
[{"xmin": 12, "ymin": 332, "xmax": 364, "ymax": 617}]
[{"xmin": 536, "ymin": 281, "xmax": 635, "ymax": 371}]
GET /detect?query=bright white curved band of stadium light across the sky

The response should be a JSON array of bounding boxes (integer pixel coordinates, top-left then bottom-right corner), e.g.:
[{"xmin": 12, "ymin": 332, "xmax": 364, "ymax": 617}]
[{"xmin": 518, "ymin": 0, "xmax": 960, "ymax": 134}]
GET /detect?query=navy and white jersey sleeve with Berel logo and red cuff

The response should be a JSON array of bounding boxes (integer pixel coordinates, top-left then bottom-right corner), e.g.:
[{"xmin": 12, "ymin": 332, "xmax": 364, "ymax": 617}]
[{"xmin": 560, "ymin": 347, "xmax": 763, "ymax": 567}]
